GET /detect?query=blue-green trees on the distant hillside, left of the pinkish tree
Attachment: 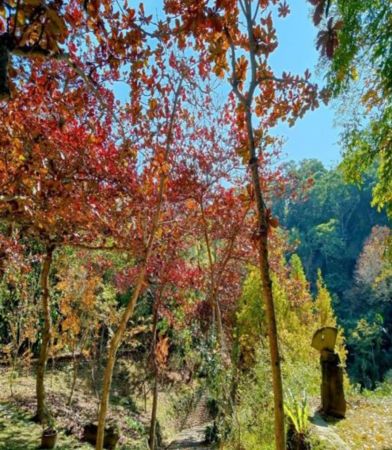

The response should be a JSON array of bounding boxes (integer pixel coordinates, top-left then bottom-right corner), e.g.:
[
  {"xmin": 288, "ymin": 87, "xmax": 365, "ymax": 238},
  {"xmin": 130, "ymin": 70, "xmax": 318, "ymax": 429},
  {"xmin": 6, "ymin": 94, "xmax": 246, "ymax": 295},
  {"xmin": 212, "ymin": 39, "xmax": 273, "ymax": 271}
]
[{"xmin": 274, "ymin": 160, "xmax": 388, "ymax": 296}]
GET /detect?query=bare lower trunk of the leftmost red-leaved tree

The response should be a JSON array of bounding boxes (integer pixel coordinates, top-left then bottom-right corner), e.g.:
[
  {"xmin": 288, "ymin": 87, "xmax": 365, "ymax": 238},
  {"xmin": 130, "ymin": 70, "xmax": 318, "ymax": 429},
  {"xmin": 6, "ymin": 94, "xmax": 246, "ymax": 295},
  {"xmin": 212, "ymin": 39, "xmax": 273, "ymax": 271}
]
[{"xmin": 35, "ymin": 245, "xmax": 54, "ymax": 423}]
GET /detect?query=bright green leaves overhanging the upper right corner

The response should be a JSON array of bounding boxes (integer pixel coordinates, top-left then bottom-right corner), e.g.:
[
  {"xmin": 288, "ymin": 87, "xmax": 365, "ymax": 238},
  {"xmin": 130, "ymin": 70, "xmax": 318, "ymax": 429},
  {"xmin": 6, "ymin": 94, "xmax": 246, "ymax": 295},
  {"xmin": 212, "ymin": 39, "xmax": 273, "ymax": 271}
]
[{"xmin": 318, "ymin": 0, "xmax": 392, "ymax": 215}]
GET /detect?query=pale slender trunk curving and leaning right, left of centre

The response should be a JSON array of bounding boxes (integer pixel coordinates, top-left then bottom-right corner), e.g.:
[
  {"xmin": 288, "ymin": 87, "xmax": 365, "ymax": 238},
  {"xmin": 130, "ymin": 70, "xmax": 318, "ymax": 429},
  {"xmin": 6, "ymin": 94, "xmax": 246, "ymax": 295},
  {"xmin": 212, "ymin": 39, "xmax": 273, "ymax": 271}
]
[{"xmin": 96, "ymin": 78, "xmax": 183, "ymax": 450}]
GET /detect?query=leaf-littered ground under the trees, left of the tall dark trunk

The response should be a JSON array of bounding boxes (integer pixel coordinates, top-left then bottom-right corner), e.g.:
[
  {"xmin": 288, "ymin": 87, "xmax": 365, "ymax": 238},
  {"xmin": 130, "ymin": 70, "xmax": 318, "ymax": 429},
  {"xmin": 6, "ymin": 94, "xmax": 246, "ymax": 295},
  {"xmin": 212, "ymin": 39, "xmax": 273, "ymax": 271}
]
[{"xmin": 0, "ymin": 367, "xmax": 208, "ymax": 450}]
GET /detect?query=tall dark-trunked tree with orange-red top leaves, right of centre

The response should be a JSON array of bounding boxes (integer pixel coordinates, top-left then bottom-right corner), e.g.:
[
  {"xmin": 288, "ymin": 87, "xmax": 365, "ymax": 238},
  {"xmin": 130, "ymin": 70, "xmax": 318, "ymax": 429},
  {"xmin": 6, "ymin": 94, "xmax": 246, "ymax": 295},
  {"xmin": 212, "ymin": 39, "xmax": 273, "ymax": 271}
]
[{"xmin": 165, "ymin": 0, "xmax": 318, "ymax": 450}]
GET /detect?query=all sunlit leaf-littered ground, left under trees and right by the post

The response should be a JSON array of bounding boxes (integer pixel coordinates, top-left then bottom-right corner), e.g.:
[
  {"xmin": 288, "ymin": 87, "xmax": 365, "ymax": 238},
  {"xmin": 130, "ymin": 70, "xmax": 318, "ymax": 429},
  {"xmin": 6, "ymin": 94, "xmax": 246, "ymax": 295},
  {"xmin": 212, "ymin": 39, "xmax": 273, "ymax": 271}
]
[{"xmin": 0, "ymin": 371, "xmax": 392, "ymax": 450}]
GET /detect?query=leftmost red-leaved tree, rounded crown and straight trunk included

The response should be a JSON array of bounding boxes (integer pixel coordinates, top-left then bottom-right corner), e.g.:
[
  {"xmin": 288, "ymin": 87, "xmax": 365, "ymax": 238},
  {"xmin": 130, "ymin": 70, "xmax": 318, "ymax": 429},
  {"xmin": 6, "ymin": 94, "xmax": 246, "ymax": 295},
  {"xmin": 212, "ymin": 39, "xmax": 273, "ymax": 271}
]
[{"xmin": 0, "ymin": 59, "xmax": 132, "ymax": 422}]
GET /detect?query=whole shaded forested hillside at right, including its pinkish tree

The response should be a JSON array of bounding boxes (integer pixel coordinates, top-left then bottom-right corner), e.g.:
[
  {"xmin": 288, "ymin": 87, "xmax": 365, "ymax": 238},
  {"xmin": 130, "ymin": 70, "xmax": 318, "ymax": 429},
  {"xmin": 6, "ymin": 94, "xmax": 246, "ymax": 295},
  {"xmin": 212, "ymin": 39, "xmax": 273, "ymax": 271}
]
[{"xmin": 274, "ymin": 160, "xmax": 392, "ymax": 388}]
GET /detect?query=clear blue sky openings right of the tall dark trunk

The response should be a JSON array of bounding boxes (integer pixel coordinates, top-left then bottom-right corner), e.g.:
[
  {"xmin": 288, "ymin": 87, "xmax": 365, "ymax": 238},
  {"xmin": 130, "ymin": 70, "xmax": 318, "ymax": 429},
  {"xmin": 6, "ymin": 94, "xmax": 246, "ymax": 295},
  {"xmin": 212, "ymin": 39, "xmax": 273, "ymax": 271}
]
[{"xmin": 272, "ymin": 0, "xmax": 341, "ymax": 166}]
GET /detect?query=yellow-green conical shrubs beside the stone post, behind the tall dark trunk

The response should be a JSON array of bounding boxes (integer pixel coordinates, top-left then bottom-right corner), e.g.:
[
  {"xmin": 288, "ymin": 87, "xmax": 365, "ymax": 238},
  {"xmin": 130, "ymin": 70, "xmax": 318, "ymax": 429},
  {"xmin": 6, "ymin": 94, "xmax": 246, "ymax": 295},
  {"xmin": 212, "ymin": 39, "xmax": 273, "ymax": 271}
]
[{"xmin": 225, "ymin": 251, "xmax": 344, "ymax": 450}]
